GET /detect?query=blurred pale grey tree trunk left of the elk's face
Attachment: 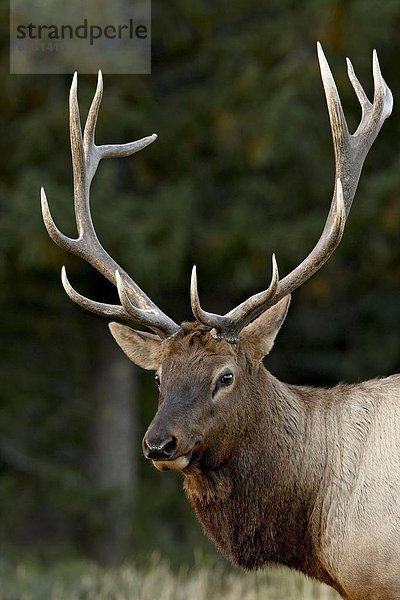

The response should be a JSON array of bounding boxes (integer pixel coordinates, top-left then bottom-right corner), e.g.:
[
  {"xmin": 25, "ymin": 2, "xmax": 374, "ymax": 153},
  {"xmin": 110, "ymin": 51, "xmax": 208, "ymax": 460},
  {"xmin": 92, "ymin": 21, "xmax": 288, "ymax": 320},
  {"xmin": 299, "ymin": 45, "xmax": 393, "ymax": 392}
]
[{"xmin": 90, "ymin": 323, "xmax": 138, "ymax": 565}]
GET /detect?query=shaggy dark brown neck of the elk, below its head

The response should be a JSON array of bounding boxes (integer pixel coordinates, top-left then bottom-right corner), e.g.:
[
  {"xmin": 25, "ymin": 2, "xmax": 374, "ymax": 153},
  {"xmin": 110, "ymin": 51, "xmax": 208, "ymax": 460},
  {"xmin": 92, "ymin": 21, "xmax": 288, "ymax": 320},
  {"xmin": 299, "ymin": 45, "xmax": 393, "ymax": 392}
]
[{"xmin": 184, "ymin": 365, "xmax": 344, "ymax": 583}]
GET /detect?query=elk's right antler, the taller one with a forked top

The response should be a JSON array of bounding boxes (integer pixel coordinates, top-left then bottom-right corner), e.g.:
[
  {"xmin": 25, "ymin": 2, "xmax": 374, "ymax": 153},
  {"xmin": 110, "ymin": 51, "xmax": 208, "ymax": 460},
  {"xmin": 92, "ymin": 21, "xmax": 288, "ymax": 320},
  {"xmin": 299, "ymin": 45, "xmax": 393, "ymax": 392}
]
[{"xmin": 190, "ymin": 43, "xmax": 393, "ymax": 342}]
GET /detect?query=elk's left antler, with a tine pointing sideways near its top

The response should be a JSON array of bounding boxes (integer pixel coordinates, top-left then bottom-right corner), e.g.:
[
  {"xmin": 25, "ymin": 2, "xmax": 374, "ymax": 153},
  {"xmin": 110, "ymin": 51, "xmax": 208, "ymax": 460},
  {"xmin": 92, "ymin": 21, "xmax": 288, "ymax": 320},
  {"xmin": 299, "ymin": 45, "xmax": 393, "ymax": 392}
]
[{"xmin": 41, "ymin": 71, "xmax": 180, "ymax": 338}]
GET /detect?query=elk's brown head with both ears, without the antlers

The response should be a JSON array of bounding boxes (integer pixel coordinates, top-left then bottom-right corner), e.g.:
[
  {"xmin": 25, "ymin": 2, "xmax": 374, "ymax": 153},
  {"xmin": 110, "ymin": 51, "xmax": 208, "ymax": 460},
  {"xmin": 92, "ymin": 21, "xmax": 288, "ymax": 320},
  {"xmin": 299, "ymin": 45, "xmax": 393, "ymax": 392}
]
[{"xmin": 110, "ymin": 296, "xmax": 290, "ymax": 470}]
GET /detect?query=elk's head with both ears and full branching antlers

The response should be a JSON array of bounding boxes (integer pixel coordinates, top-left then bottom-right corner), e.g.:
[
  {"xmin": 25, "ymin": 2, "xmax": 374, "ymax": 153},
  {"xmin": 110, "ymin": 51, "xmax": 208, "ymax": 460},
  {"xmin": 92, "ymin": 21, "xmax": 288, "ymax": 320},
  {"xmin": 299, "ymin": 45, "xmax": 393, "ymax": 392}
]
[{"xmin": 42, "ymin": 44, "xmax": 392, "ymax": 470}]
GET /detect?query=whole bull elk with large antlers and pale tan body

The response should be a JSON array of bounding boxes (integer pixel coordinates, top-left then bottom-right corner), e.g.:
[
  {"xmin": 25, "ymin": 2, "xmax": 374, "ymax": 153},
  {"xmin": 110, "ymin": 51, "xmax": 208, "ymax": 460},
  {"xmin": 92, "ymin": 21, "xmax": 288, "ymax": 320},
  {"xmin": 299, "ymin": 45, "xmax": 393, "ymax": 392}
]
[{"xmin": 42, "ymin": 45, "xmax": 400, "ymax": 600}]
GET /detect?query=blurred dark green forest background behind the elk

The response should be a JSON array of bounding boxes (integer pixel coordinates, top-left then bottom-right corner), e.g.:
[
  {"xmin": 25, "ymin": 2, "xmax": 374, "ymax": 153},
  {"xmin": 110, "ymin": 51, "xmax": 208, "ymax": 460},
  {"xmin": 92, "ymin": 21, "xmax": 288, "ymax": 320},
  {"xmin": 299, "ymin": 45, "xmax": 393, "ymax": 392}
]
[{"xmin": 0, "ymin": 0, "xmax": 400, "ymax": 588}]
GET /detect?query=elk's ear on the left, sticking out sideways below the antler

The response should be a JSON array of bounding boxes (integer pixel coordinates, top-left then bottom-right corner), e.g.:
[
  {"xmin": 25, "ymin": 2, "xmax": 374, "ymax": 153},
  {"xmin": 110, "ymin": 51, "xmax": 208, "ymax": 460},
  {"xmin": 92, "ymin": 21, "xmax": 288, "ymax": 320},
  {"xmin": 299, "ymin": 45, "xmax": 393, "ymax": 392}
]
[{"xmin": 109, "ymin": 323, "xmax": 161, "ymax": 371}]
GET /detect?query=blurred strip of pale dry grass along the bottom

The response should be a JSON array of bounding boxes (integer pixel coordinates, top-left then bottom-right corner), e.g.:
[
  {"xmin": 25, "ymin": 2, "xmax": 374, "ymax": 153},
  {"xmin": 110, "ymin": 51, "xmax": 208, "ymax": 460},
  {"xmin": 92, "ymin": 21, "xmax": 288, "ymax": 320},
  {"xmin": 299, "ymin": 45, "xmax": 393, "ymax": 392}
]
[{"xmin": 0, "ymin": 557, "xmax": 339, "ymax": 600}]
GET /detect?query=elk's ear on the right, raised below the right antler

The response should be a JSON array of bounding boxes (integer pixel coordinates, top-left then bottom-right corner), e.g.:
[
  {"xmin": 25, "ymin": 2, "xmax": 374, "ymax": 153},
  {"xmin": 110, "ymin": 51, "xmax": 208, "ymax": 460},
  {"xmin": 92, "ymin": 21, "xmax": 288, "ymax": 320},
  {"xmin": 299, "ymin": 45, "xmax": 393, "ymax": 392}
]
[{"xmin": 240, "ymin": 295, "xmax": 290, "ymax": 360}]
